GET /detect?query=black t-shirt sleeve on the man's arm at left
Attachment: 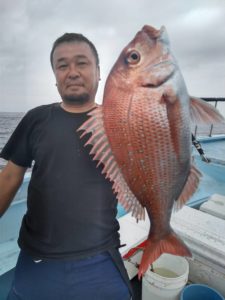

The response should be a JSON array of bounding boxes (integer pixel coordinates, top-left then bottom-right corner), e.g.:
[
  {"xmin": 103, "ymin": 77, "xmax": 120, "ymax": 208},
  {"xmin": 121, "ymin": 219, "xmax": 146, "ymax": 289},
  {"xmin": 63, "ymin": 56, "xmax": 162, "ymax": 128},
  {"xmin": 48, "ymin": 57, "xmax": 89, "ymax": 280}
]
[{"xmin": 0, "ymin": 113, "xmax": 32, "ymax": 168}]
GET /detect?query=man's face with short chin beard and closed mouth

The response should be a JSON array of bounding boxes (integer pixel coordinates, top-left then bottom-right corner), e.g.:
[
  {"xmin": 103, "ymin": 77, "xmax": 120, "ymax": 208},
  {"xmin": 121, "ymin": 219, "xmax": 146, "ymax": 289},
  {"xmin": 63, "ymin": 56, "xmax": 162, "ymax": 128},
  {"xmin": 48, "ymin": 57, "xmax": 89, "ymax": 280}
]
[{"xmin": 53, "ymin": 42, "xmax": 100, "ymax": 105}]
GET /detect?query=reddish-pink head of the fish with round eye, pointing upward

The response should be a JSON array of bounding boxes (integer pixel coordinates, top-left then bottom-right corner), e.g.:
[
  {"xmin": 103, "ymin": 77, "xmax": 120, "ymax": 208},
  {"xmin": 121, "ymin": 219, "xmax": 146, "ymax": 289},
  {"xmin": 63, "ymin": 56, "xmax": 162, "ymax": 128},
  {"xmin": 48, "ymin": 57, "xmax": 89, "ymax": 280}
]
[{"xmin": 103, "ymin": 25, "xmax": 176, "ymax": 103}]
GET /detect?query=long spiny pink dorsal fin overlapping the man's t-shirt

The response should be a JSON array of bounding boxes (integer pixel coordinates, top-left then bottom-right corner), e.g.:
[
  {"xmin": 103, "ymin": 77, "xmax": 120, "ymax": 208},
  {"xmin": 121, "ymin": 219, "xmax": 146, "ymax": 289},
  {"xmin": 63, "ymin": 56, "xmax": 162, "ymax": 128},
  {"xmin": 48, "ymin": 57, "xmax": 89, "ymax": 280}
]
[{"xmin": 77, "ymin": 106, "xmax": 145, "ymax": 220}]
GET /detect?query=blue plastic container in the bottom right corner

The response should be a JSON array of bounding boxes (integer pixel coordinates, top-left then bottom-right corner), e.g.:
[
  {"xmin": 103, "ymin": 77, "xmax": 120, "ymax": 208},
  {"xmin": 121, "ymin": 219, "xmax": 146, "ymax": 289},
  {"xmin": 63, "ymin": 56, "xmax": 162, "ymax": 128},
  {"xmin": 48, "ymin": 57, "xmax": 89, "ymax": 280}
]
[{"xmin": 180, "ymin": 284, "xmax": 225, "ymax": 300}]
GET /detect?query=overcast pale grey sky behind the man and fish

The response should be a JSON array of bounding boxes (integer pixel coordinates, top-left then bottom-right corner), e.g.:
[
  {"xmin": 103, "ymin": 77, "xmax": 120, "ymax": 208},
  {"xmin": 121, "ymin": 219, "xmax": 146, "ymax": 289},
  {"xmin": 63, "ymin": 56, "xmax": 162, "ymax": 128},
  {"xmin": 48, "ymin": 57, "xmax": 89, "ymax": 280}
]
[{"xmin": 0, "ymin": 0, "xmax": 225, "ymax": 112}]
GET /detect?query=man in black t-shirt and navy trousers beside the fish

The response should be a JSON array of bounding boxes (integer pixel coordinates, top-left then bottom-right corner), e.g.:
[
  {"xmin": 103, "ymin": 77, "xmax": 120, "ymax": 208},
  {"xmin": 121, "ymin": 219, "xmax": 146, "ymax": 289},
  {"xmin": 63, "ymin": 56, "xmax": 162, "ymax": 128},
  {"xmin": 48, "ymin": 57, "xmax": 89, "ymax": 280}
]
[{"xmin": 0, "ymin": 33, "xmax": 131, "ymax": 300}]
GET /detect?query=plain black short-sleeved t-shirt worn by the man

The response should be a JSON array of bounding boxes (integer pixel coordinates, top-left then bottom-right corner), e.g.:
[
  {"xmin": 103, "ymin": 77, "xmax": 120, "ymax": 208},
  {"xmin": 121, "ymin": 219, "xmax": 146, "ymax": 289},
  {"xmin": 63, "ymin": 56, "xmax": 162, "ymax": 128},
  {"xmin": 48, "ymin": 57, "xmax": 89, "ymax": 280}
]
[{"xmin": 0, "ymin": 103, "xmax": 119, "ymax": 259}]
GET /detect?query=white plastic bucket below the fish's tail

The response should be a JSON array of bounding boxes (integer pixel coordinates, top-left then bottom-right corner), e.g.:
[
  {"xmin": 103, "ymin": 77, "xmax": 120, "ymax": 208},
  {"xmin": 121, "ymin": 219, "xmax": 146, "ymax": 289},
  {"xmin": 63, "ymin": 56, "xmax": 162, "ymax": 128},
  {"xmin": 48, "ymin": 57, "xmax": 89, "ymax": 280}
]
[{"xmin": 142, "ymin": 253, "xmax": 189, "ymax": 300}]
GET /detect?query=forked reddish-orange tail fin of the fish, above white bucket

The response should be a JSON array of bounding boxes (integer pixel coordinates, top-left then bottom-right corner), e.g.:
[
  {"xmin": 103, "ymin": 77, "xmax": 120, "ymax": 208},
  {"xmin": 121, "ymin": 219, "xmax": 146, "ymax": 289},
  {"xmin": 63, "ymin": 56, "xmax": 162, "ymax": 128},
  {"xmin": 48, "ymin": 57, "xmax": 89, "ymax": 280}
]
[{"xmin": 138, "ymin": 231, "xmax": 192, "ymax": 279}]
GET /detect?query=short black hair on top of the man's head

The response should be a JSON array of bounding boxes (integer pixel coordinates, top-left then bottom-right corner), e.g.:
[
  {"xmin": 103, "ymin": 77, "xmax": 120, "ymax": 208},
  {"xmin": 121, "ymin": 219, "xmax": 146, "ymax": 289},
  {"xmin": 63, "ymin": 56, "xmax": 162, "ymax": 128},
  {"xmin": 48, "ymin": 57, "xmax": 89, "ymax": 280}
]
[{"xmin": 50, "ymin": 33, "xmax": 99, "ymax": 68}]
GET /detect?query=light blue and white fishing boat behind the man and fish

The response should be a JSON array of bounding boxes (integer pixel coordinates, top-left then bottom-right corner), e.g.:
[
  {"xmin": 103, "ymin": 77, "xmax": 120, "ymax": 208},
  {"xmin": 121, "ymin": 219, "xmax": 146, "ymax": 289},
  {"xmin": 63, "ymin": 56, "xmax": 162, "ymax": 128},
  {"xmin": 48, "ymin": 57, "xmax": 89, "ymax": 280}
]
[{"xmin": 0, "ymin": 98, "xmax": 225, "ymax": 300}]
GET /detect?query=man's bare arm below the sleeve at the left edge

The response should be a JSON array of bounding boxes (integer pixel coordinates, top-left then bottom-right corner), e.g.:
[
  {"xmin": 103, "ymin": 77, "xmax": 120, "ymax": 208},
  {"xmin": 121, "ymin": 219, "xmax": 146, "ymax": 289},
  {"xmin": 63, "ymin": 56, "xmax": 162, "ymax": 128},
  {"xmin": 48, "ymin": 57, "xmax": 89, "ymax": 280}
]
[{"xmin": 0, "ymin": 161, "xmax": 26, "ymax": 217}]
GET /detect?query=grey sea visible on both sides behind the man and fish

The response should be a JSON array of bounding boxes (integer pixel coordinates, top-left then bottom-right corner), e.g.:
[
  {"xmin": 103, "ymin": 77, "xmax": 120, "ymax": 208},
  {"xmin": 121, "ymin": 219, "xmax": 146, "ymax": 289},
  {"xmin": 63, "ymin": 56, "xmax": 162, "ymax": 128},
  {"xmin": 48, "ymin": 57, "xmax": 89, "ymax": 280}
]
[{"xmin": 0, "ymin": 112, "xmax": 225, "ymax": 170}]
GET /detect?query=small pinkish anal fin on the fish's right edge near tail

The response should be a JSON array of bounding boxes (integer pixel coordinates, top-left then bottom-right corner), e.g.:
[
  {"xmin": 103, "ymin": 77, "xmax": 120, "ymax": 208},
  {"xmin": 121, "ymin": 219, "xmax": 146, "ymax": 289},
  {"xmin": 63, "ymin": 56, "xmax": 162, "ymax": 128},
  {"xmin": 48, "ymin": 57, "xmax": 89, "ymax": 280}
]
[{"xmin": 174, "ymin": 164, "xmax": 202, "ymax": 210}]
